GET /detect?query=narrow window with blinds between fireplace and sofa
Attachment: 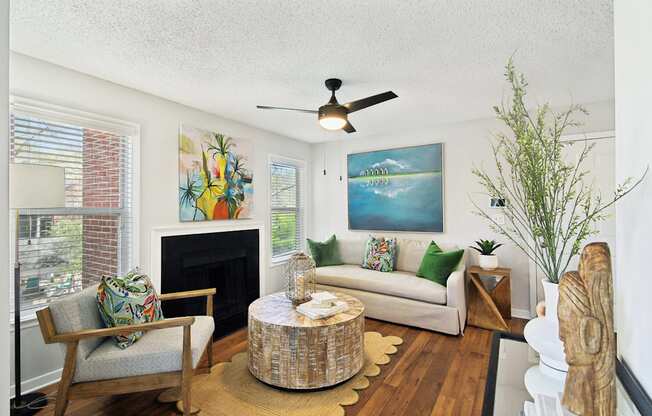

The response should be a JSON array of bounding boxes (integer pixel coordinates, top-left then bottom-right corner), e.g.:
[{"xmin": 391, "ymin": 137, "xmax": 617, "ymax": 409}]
[{"xmin": 270, "ymin": 158, "xmax": 305, "ymax": 261}]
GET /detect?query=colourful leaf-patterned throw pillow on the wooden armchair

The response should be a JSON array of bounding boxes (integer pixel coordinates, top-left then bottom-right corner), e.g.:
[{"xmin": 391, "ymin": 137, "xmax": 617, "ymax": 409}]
[{"xmin": 97, "ymin": 270, "xmax": 163, "ymax": 349}]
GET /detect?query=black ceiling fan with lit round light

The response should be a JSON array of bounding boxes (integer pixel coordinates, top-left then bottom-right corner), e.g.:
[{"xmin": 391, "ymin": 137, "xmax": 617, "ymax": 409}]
[{"xmin": 256, "ymin": 78, "xmax": 398, "ymax": 133}]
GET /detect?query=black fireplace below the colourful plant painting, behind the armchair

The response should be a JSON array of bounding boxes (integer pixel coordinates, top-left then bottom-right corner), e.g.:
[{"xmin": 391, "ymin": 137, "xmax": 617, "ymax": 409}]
[{"xmin": 161, "ymin": 230, "xmax": 260, "ymax": 339}]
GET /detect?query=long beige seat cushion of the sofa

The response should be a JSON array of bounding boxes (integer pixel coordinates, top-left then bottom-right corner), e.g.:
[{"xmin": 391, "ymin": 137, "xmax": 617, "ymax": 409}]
[{"xmin": 316, "ymin": 264, "xmax": 446, "ymax": 305}]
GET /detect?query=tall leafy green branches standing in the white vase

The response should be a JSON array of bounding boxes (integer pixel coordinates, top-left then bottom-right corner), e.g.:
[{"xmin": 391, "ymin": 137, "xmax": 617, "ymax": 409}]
[{"xmin": 473, "ymin": 59, "xmax": 647, "ymax": 321}]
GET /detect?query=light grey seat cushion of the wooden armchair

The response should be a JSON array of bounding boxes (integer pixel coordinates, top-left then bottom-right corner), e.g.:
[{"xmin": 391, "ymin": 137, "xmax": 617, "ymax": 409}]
[{"xmin": 73, "ymin": 316, "xmax": 215, "ymax": 383}]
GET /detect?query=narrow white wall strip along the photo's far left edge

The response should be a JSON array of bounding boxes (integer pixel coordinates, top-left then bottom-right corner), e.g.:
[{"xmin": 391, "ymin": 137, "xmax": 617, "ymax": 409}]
[{"xmin": 0, "ymin": 0, "xmax": 11, "ymax": 416}]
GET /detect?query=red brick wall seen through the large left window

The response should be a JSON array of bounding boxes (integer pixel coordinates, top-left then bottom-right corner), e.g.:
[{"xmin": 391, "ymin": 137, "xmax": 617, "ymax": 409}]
[{"xmin": 82, "ymin": 129, "xmax": 122, "ymax": 282}]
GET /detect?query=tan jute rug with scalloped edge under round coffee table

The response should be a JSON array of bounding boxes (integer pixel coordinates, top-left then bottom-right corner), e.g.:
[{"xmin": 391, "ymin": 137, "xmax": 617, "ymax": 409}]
[{"xmin": 178, "ymin": 332, "xmax": 403, "ymax": 416}]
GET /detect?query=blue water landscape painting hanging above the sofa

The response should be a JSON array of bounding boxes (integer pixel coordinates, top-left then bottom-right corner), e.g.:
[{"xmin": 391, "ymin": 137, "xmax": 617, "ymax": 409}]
[{"xmin": 347, "ymin": 143, "xmax": 444, "ymax": 232}]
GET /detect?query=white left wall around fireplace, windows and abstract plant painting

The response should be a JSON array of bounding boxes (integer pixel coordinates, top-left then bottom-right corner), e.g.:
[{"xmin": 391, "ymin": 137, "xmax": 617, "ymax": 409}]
[{"xmin": 8, "ymin": 53, "xmax": 310, "ymax": 394}]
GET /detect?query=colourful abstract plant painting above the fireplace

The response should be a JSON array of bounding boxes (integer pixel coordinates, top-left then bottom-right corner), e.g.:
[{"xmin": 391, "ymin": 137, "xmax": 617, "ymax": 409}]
[{"xmin": 179, "ymin": 125, "xmax": 253, "ymax": 221}]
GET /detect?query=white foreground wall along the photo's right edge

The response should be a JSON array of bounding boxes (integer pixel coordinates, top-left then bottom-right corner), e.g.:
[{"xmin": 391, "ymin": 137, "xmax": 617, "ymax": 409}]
[{"xmin": 614, "ymin": 0, "xmax": 652, "ymax": 394}]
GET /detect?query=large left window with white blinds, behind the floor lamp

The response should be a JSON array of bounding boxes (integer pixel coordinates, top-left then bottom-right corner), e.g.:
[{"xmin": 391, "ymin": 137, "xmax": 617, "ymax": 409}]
[{"xmin": 10, "ymin": 104, "xmax": 137, "ymax": 319}]
